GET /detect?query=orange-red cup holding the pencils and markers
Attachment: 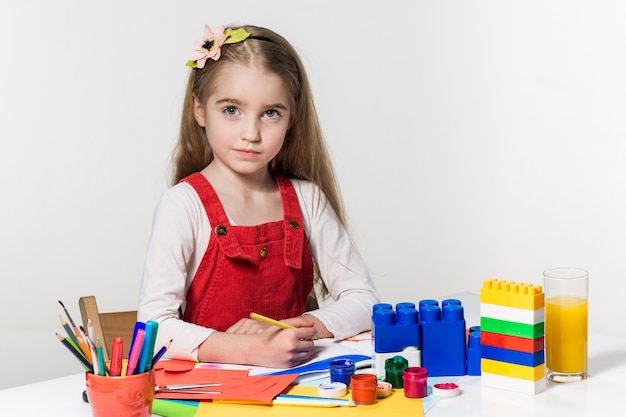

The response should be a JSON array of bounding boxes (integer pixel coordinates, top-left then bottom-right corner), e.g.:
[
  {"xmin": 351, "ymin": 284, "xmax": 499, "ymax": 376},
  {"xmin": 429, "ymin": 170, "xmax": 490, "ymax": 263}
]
[{"xmin": 86, "ymin": 370, "xmax": 154, "ymax": 417}]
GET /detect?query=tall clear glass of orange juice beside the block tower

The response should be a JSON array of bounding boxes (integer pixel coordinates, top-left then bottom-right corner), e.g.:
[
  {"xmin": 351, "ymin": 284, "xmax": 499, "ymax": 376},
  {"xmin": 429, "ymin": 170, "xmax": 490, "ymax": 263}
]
[{"xmin": 543, "ymin": 268, "xmax": 589, "ymax": 382}]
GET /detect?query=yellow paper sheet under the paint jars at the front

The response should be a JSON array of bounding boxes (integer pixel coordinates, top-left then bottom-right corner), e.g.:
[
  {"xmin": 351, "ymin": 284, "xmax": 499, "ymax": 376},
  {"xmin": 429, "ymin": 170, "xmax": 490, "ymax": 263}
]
[{"xmin": 195, "ymin": 386, "xmax": 424, "ymax": 417}]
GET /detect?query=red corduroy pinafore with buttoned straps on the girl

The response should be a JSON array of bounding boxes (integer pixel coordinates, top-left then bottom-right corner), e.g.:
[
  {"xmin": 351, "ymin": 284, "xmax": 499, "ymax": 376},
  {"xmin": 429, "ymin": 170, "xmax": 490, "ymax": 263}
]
[{"xmin": 183, "ymin": 173, "xmax": 313, "ymax": 331}]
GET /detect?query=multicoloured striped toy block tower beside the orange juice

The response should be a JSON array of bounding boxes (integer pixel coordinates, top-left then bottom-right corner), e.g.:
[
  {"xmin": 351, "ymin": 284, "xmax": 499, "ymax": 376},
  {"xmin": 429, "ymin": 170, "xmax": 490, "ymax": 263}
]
[{"xmin": 480, "ymin": 279, "xmax": 546, "ymax": 394}]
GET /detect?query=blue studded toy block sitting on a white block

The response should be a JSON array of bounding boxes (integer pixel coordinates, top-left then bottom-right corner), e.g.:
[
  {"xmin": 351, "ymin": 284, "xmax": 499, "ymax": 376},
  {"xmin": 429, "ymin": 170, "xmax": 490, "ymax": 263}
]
[{"xmin": 372, "ymin": 303, "xmax": 421, "ymax": 353}]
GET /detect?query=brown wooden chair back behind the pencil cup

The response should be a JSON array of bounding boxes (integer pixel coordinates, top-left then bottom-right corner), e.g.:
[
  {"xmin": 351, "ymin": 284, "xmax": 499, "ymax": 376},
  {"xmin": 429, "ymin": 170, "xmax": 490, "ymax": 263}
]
[{"xmin": 78, "ymin": 295, "xmax": 137, "ymax": 361}]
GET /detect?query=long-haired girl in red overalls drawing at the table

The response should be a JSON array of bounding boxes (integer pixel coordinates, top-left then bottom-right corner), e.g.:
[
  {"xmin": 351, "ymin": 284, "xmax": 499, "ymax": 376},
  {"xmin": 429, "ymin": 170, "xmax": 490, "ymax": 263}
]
[{"xmin": 138, "ymin": 26, "xmax": 379, "ymax": 368}]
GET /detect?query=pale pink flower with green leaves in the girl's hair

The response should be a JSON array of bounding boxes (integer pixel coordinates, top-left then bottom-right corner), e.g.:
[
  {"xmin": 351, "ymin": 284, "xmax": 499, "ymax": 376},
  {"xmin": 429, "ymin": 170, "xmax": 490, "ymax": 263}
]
[{"xmin": 185, "ymin": 25, "xmax": 250, "ymax": 68}]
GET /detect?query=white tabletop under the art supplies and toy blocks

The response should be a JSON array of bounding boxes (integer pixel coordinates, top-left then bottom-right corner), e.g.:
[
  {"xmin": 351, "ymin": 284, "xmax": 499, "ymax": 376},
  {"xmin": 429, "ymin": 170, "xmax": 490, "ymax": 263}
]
[{"xmin": 0, "ymin": 293, "xmax": 626, "ymax": 417}]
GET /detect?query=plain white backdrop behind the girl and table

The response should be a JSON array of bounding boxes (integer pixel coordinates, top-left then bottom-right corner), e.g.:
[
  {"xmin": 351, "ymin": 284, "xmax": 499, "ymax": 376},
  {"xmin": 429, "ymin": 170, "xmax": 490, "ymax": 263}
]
[{"xmin": 0, "ymin": 0, "xmax": 626, "ymax": 388}]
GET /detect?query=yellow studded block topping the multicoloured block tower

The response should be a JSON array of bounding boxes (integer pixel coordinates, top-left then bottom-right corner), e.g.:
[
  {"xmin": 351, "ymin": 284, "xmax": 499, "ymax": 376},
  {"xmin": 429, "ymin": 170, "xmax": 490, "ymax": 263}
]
[{"xmin": 480, "ymin": 278, "xmax": 544, "ymax": 310}]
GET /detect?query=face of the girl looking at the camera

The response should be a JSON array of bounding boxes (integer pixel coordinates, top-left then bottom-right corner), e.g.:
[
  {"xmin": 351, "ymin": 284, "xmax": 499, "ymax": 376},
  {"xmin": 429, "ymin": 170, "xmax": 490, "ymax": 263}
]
[{"xmin": 194, "ymin": 63, "xmax": 291, "ymax": 176}]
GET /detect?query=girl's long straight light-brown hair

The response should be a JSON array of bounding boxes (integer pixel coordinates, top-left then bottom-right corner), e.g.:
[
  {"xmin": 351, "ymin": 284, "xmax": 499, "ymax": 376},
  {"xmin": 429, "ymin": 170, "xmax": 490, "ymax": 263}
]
[{"xmin": 172, "ymin": 26, "xmax": 345, "ymax": 225}]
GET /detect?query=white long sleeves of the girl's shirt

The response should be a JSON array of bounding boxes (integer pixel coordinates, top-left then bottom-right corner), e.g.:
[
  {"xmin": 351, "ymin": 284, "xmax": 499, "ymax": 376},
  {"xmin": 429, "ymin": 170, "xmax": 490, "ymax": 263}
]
[{"xmin": 138, "ymin": 180, "xmax": 380, "ymax": 361}]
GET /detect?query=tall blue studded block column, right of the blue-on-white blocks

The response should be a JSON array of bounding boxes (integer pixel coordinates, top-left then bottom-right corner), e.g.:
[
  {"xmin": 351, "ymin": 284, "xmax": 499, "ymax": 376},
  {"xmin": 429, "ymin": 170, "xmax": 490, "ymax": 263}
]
[{"xmin": 419, "ymin": 300, "xmax": 467, "ymax": 376}]
